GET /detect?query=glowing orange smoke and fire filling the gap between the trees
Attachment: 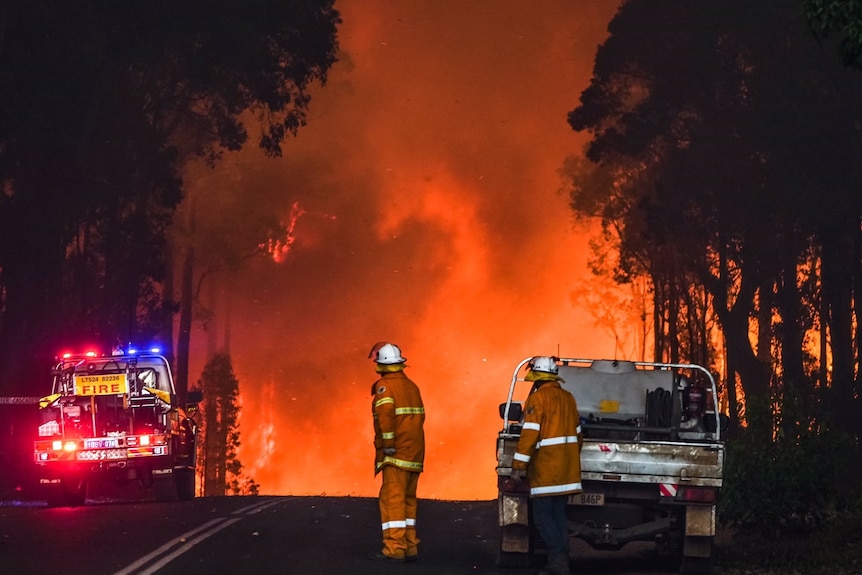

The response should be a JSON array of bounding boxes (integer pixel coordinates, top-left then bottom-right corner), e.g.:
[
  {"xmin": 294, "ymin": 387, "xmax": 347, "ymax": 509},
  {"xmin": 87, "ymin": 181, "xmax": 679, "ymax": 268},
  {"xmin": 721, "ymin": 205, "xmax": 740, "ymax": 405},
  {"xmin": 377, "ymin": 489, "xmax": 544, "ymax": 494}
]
[{"xmin": 187, "ymin": 0, "xmax": 616, "ymax": 499}]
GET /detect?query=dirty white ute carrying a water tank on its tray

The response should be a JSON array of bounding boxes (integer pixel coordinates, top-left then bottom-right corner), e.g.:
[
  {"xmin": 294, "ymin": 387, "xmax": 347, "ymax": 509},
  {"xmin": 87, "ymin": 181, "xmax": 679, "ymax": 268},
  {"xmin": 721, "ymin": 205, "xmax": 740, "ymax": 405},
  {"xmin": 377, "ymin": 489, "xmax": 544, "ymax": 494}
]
[{"xmin": 497, "ymin": 357, "xmax": 727, "ymax": 574}]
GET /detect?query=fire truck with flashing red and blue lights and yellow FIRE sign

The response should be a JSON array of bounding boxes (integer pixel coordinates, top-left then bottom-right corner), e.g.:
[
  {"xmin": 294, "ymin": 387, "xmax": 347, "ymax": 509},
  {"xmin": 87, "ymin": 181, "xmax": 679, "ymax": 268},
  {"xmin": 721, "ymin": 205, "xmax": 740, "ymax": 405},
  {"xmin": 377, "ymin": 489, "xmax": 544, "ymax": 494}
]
[{"xmin": 34, "ymin": 350, "xmax": 200, "ymax": 506}]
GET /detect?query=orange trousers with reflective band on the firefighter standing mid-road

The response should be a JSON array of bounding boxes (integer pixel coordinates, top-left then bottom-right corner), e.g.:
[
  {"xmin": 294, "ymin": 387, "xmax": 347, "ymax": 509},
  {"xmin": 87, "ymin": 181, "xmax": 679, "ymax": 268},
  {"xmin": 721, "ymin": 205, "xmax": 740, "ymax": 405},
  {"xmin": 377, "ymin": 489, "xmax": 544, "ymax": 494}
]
[{"xmin": 379, "ymin": 465, "xmax": 419, "ymax": 559}]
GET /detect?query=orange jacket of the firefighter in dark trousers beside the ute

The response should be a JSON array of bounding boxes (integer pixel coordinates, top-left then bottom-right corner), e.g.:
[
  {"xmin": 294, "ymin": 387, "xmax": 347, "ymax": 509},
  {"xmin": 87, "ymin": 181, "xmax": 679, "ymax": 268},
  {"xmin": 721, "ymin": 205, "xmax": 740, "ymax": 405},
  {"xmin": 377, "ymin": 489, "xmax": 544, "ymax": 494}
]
[{"xmin": 512, "ymin": 380, "xmax": 583, "ymax": 497}]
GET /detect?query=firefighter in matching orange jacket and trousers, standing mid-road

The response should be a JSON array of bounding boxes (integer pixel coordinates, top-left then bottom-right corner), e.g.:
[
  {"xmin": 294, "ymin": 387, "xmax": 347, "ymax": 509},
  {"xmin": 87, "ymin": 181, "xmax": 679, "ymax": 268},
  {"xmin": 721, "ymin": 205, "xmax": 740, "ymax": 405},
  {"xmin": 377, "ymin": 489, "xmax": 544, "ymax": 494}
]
[{"xmin": 369, "ymin": 342, "xmax": 425, "ymax": 562}]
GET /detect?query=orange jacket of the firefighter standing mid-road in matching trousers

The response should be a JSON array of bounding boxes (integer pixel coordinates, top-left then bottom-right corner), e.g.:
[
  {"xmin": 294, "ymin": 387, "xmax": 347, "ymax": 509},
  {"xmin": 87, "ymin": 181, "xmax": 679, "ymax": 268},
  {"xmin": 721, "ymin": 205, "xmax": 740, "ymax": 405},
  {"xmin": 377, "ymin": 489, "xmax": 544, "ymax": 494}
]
[{"xmin": 371, "ymin": 371, "xmax": 425, "ymax": 475}]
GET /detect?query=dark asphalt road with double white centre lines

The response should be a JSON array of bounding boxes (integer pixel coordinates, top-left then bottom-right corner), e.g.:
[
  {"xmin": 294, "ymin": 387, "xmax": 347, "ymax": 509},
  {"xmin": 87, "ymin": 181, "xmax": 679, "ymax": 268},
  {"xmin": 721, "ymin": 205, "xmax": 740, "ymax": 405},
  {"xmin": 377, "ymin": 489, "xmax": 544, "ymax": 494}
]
[{"xmin": 0, "ymin": 490, "xmax": 684, "ymax": 575}]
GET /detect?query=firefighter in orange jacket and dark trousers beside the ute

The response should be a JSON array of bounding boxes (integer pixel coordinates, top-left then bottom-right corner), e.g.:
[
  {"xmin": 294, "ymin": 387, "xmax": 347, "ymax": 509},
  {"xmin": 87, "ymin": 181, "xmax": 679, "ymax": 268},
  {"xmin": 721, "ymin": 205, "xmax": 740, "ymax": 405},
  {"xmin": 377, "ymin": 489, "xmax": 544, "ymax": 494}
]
[{"xmin": 512, "ymin": 356, "xmax": 583, "ymax": 575}]
